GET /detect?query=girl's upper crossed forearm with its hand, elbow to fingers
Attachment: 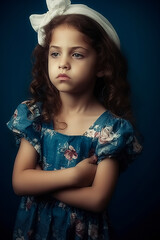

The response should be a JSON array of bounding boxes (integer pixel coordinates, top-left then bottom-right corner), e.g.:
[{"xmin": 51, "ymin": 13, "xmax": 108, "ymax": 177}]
[{"xmin": 12, "ymin": 158, "xmax": 97, "ymax": 195}]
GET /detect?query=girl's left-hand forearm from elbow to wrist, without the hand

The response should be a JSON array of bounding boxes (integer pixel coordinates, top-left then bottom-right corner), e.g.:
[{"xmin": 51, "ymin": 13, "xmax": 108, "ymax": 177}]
[{"xmin": 12, "ymin": 168, "xmax": 76, "ymax": 195}]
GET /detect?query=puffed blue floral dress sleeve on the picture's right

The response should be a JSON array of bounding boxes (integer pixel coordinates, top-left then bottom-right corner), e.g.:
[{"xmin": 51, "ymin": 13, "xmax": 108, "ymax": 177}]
[{"xmin": 95, "ymin": 119, "xmax": 142, "ymax": 171}]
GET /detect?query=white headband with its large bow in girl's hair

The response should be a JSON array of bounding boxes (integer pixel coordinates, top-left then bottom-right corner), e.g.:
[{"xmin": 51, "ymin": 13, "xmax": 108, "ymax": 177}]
[{"xmin": 29, "ymin": 0, "xmax": 120, "ymax": 48}]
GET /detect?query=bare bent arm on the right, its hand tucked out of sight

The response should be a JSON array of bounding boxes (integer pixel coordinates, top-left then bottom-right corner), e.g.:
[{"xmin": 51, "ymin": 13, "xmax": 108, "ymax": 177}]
[{"xmin": 53, "ymin": 158, "xmax": 119, "ymax": 212}]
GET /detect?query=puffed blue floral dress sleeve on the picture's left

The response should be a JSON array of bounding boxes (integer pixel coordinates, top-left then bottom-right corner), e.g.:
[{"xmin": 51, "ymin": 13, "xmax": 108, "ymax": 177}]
[{"xmin": 7, "ymin": 101, "xmax": 41, "ymax": 154}]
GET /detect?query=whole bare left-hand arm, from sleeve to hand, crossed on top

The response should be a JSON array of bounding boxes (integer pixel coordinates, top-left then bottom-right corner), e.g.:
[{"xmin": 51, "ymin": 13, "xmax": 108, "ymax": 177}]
[{"xmin": 12, "ymin": 138, "xmax": 96, "ymax": 195}]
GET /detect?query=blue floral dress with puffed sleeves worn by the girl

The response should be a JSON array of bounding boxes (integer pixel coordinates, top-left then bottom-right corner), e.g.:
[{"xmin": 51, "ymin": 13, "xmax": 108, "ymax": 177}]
[{"xmin": 7, "ymin": 102, "xmax": 141, "ymax": 240}]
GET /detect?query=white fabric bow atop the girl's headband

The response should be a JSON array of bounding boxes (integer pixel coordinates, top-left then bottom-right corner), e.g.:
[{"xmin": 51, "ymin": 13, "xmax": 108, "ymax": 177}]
[{"xmin": 29, "ymin": 0, "xmax": 71, "ymax": 46}]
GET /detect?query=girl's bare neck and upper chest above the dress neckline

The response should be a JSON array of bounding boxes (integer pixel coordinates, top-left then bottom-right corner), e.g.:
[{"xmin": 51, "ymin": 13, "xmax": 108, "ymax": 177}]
[{"xmin": 53, "ymin": 93, "xmax": 106, "ymax": 135}]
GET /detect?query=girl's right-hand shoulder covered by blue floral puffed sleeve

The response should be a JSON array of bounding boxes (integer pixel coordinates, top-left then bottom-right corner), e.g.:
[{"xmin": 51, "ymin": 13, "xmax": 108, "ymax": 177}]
[{"xmin": 92, "ymin": 111, "xmax": 142, "ymax": 170}]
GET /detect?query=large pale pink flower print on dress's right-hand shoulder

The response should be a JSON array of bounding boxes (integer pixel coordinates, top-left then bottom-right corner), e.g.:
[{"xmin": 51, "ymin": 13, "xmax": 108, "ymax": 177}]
[{"xmin": 97, "ymin": 127, "xmax": 116, "ymax": 144}]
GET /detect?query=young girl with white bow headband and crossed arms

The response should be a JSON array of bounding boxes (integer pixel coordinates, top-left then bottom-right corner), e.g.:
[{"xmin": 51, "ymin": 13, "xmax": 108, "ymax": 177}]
[{"xmin": 8, "ymin": 0, "xmax": 141, "ymax": 240}]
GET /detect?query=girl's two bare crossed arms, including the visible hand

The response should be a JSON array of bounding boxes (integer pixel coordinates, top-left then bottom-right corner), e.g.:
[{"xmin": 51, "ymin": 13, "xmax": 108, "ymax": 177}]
[{"xmin": 12, "ymin": 139, "xmax": 119, "ymax": 212}]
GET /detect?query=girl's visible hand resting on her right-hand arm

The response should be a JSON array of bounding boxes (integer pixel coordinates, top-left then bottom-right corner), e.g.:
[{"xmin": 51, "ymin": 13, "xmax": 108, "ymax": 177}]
[{"xmin": 75, "ymin": 155, "xmax": 97, "ymax": 187}]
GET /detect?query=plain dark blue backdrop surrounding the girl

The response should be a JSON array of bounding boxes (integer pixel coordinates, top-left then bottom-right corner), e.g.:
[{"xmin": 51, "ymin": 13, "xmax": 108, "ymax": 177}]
[{"xmin": 0, "ymin": 0, "xmax": 160, "ymax": 240}]
